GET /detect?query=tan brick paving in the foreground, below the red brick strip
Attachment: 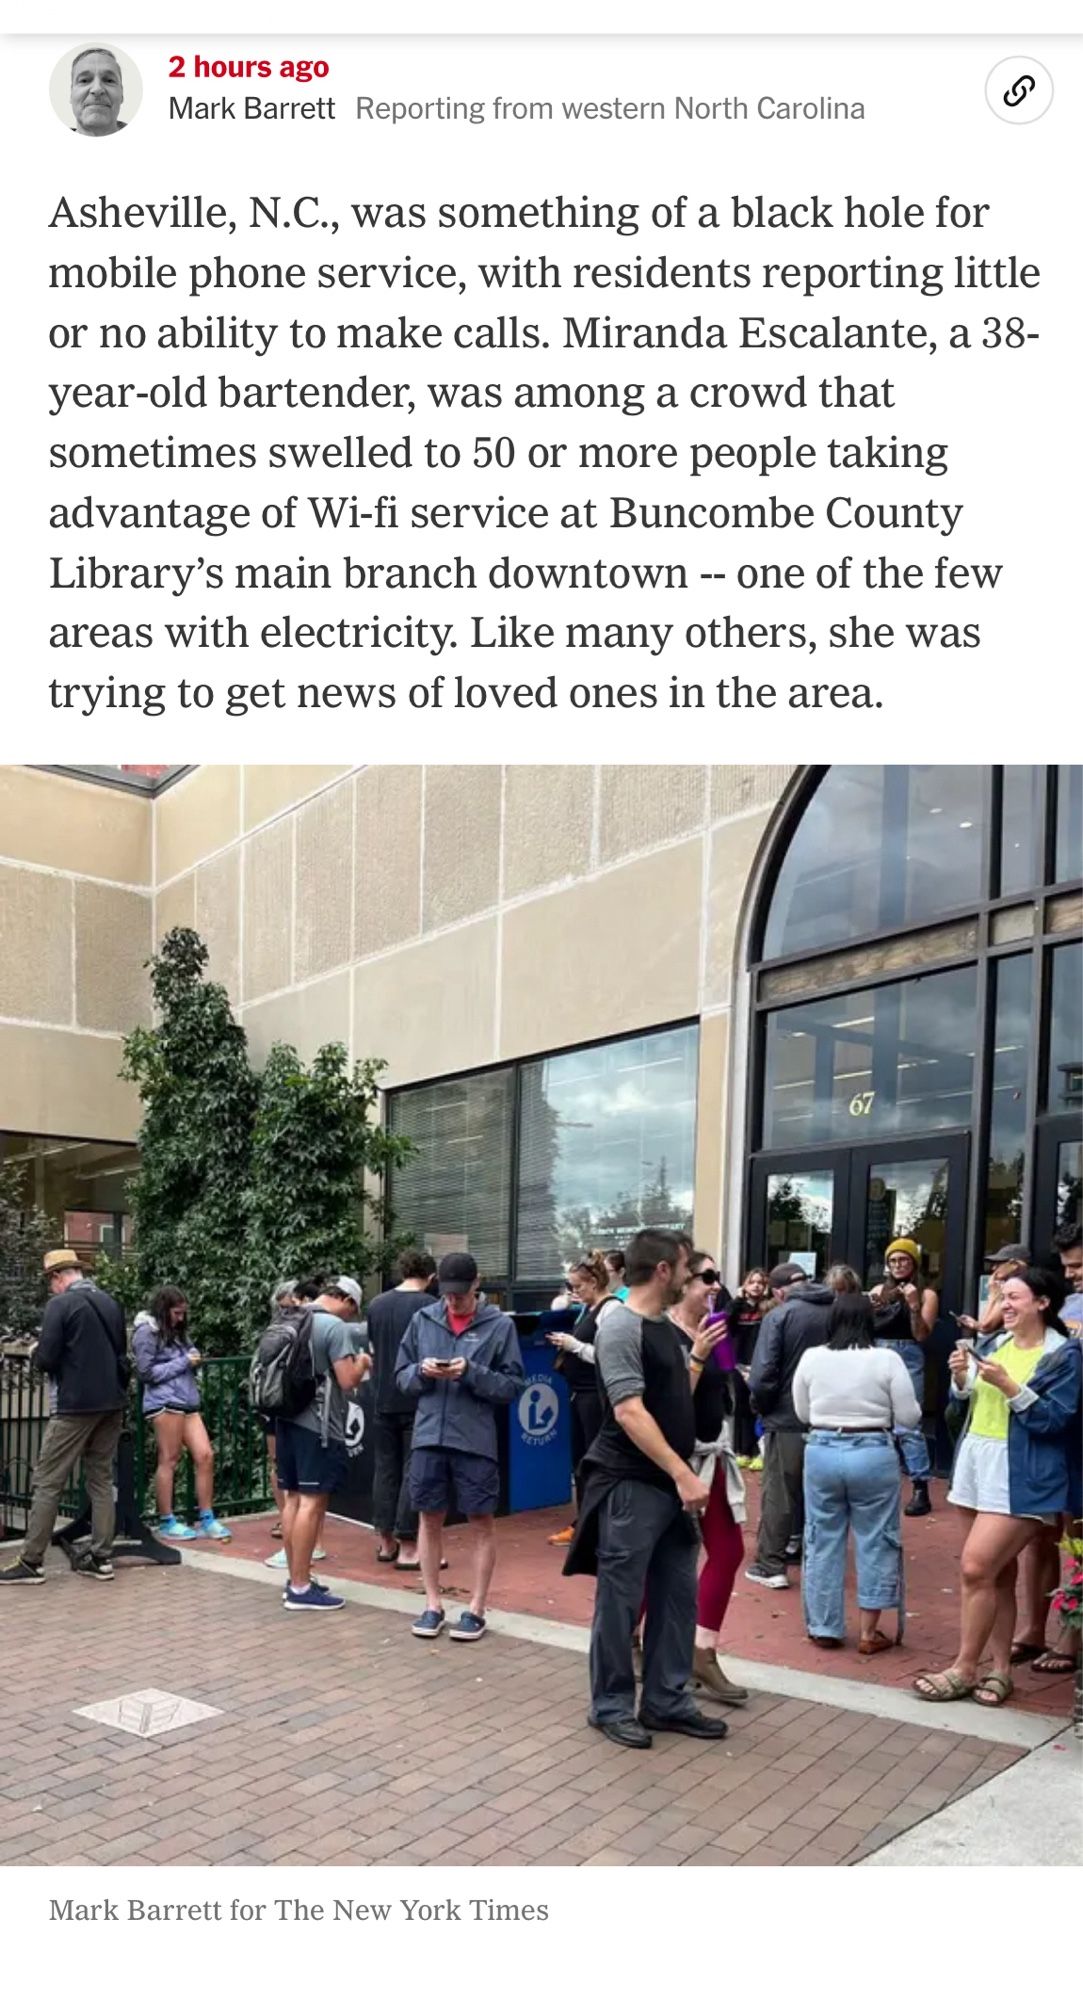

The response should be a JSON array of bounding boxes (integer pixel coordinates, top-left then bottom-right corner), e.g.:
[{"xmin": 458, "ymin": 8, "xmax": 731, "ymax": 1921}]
[{"xmin": 0, "ymin": 1556, "xmax": 1021, "ymax": 1868}]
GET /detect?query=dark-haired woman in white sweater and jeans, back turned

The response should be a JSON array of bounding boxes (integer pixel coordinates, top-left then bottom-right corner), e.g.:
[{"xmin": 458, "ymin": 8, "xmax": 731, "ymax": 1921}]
[{"xmin": 793, "ymin": 1292, "xmax": 921, "ymax": 1654}]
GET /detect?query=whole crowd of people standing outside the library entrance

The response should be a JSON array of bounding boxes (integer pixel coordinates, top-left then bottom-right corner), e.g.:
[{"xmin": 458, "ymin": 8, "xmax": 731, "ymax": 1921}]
[{"xmin": 0, "ymin": 1226, "xmax": 1083, "ymax": 1748}]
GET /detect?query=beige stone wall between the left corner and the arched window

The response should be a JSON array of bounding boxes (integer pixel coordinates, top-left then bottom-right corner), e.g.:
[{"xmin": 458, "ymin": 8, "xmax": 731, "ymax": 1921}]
[{"xmin": 154, "ymin": 764, "xmax": 793, "ymax": 1248}]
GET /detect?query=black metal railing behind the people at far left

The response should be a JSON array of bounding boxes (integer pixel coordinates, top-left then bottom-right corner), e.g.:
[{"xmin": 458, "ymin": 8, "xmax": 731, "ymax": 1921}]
[{"xmin": 0, "ymin": 1342, "xmax": 274, "ymax": 1536}]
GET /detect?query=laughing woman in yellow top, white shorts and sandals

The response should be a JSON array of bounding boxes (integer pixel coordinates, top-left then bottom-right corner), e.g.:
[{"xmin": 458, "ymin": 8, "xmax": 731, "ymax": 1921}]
[{"xmin": 913, "ymin": 1266, "xmax": 1081, "ymax": 1708}]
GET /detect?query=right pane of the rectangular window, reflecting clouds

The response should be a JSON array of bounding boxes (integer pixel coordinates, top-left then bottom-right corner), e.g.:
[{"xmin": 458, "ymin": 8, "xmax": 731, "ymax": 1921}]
[{"xmin": 518, "ymin": 1028, "xmax": 699, "ymax": 1278}]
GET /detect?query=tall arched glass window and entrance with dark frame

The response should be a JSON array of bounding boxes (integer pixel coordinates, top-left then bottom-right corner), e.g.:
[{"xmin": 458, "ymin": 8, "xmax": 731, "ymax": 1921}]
[{"xmin": 745, "ymin": 764, "xmax": 1083, "ymax": 1310}]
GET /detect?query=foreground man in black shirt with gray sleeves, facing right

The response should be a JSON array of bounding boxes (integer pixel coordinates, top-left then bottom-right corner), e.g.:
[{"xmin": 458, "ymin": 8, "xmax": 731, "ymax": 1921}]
[{"xmin": 563, "ymin": 1230, "xmax": 725, "ymax": 1750}]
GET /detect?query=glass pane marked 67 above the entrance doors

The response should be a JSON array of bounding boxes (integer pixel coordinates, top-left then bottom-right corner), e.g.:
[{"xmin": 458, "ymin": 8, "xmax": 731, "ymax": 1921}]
[{"xmin": 763, "ymin": 966, "xmax": 977, "ymax": 1146}]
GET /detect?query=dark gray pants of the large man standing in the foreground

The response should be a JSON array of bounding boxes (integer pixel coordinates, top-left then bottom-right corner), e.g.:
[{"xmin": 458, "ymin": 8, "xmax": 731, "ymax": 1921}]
[{"xmin": 589, "ymin": 1480, "xmax": 699, "ymax": 1722}]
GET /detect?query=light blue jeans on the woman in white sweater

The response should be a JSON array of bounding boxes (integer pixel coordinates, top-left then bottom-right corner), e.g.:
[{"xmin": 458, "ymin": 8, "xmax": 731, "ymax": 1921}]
[{"xmin": 801, "ymin": 1430, "xmax": 903, "ymax": 1638}]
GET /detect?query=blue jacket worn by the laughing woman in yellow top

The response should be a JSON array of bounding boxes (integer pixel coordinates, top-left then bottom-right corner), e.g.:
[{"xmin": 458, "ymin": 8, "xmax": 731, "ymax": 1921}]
[{"xmin": 951, "ymin": 1332, "xmax": 1083, "ymax": 1516}]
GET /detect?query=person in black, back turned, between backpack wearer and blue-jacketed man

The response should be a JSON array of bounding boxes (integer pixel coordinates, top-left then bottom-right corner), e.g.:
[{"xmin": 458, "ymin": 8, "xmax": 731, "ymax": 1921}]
[{"xmin": 368, "ymin": 1250, "xmax": 436, "ymax": 1570}]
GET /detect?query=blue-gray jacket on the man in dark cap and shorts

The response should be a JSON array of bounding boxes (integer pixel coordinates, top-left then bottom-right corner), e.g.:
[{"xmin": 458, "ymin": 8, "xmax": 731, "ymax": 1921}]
[{"xmin": 396, "ymin": 1298, "xmax": 526, "ymax": 1458}]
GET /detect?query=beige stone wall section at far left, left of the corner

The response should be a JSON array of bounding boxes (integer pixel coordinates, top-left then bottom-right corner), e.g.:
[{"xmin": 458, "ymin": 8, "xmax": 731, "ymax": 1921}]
[{"xmin": 0, "ymin": 766, "xmax": 154, "ymax": 1140}]
